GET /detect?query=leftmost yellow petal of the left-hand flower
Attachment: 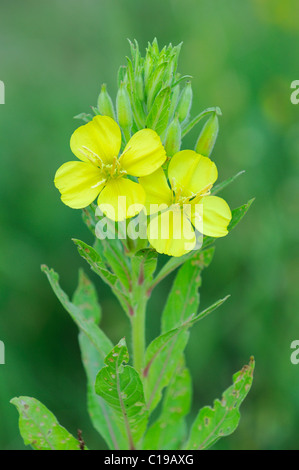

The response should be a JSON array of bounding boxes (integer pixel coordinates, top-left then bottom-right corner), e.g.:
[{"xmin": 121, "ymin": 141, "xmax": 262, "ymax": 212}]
[{"xmin": 54, "ymin": 162, "xmax": 105, "ymax": 209}]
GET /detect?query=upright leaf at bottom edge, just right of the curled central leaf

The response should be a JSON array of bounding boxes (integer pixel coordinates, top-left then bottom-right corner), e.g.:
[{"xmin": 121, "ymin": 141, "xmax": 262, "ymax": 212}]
[{"xmin": 143, "ymin": 361, "xmax": 191, "ymax": 450}]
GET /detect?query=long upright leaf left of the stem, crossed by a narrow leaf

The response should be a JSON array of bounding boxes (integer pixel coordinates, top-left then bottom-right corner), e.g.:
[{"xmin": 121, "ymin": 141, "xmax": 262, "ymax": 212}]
[{"xmin": 72, "ymin": 271, "xmax": 127, "ymax": 449}]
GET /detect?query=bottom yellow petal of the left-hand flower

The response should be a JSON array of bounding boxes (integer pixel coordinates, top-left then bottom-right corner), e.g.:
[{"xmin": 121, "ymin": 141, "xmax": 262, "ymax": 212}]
[{"xmin": 98, "ymin": 178, "xmax": 145, "ymax": 221}]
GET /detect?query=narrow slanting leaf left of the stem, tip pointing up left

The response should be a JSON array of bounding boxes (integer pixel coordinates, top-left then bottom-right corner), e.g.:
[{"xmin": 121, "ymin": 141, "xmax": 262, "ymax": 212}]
[{"xmin": 42, "ymin": 265, "xmax": 112, "ymax": 359}]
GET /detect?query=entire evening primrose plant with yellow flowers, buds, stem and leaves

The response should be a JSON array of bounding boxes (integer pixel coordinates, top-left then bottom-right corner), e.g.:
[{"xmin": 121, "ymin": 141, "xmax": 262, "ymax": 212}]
[{"xmin": 12, "ymin": 40, "xmax": 254, "ymax": 450}]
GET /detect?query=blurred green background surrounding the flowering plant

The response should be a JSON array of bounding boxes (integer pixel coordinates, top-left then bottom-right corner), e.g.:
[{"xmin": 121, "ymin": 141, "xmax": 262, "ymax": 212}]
[{"xmin": 0, "ymin": 0, "xmax": 299, "ymax": 449}]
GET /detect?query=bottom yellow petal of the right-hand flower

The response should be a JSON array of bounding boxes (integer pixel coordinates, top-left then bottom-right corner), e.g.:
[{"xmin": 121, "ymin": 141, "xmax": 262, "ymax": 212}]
[{"xmin": 147, "ymin": 207, "xmax": 196, "ymax": 257}]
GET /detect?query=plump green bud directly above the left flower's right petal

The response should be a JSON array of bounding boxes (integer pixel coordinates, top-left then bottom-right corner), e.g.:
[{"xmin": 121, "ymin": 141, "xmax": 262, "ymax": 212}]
[{"xmin": 146, "ymin": 87, "xmax": 171, "ymax": 135}]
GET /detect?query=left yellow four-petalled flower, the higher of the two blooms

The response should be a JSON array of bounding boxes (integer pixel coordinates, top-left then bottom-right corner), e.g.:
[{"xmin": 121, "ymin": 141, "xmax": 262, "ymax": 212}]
[{"xmin": 54, "ymin": 116, "xmax": 166, "ymax": 220}]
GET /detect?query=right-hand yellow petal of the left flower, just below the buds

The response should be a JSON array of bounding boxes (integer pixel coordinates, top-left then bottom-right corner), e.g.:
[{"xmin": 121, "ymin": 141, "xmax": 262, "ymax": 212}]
[{"xmin": 120, "ymin": 129, "xmax": 166, "ymax": 176}]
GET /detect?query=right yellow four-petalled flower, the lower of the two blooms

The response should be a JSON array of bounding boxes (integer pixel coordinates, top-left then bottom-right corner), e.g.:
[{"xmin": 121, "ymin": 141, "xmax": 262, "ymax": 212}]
[{"xmin": 139, "ymin": 150, "xmax": 232, "ymax": 257}]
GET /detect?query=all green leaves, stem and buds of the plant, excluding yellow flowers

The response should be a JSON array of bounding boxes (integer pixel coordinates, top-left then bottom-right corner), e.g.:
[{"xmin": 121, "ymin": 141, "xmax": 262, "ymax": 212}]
[{"xmin": 13, "ymin": 39, "xmax": 254, "ymax": 450}]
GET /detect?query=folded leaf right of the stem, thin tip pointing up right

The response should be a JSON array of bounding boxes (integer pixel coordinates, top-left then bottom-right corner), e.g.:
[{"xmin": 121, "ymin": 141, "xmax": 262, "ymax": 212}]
[{"xmin": 143, "ymin": 296, "xmax": 229, "ymax": 411}]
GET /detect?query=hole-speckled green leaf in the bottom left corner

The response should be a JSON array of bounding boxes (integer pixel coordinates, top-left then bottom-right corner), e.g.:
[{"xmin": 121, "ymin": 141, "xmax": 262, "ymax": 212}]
[{"xmin": 10, "ymin": 397, "xmax": 80, "ymax": 450}]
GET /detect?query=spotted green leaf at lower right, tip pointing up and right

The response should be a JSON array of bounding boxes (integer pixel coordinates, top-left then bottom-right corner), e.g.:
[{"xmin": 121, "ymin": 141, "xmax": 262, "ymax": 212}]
[{"xmin": 184, "ymin": 358, "xmax": 254, "ymax": 450}]
